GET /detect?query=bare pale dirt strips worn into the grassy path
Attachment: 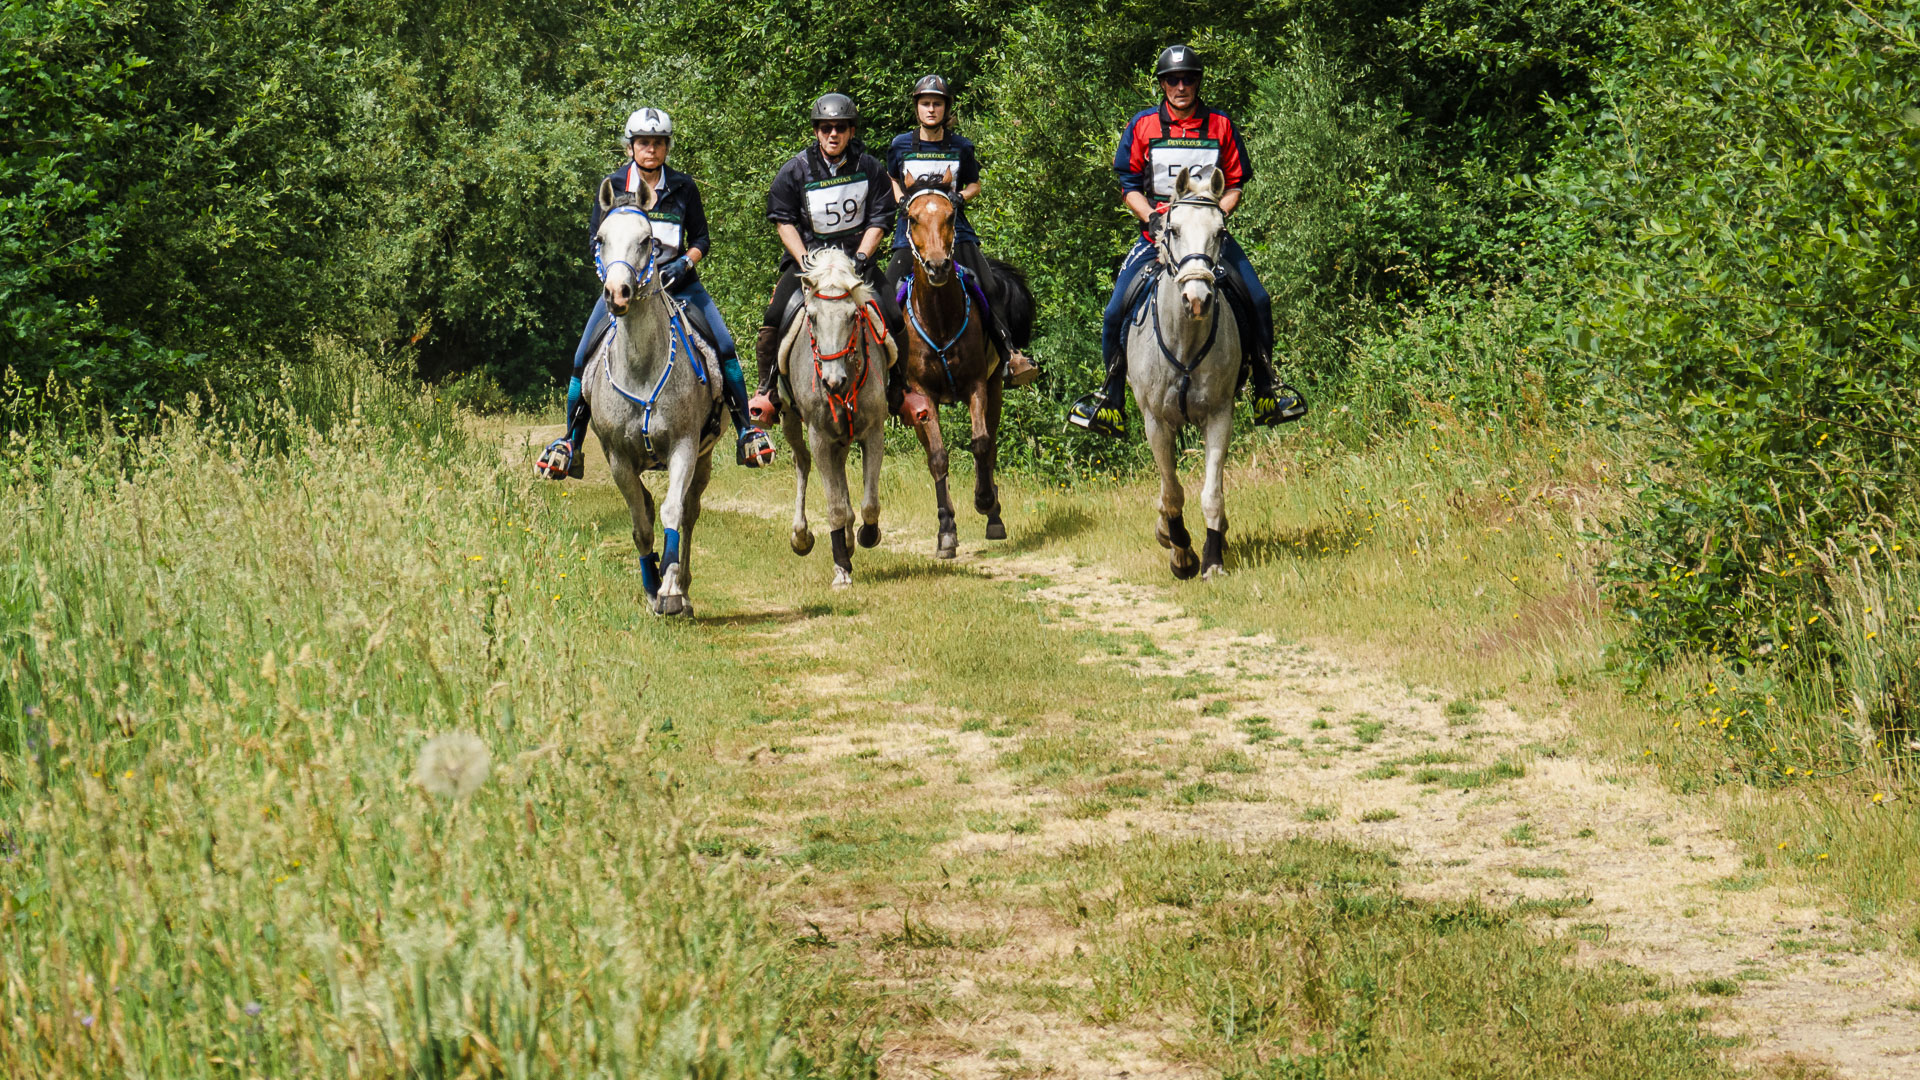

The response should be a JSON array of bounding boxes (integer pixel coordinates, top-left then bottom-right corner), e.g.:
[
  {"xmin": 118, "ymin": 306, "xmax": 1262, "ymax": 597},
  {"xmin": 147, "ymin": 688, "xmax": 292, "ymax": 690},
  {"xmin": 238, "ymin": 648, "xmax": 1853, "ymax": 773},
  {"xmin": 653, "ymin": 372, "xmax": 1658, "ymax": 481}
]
[{"xmin": 511, "ymin": 429, "xmax": 1920, "ymax": 1080}]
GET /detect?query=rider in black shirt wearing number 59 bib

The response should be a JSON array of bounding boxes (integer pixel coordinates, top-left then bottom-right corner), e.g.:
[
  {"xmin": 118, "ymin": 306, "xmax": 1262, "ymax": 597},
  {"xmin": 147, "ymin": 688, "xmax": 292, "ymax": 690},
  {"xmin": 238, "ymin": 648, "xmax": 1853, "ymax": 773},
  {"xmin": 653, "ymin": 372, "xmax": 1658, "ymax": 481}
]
[{"xmin": 749, "ymin": 94, "xmax": 904, "ymax": 425}]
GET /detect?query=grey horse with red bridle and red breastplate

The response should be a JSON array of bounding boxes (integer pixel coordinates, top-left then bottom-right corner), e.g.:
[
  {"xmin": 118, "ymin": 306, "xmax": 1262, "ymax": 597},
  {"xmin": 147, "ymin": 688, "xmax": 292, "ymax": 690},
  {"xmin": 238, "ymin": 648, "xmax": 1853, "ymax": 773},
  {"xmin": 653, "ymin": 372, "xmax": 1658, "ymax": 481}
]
[{"xmin": 780, "ymin": 248, "xmax": 895, "ymax": 588}]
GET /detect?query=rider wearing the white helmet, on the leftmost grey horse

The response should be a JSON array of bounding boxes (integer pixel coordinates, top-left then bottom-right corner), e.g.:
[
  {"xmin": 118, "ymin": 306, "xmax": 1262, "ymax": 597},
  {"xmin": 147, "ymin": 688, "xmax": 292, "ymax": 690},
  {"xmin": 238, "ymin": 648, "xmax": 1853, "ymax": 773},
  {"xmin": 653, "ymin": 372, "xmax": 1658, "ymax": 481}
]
[{"xmin": 536, "ymin": 110, "xmax": 774, "ymax": 480}]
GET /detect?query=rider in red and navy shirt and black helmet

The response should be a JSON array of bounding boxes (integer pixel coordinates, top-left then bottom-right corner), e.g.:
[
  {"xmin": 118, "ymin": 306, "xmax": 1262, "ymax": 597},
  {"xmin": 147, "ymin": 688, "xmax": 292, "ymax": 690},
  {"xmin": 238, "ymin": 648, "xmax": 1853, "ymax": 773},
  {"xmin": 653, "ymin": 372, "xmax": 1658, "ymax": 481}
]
[{"xmin": 1068, "ymin": 44, "xmax": 1306, "ymax": 436}]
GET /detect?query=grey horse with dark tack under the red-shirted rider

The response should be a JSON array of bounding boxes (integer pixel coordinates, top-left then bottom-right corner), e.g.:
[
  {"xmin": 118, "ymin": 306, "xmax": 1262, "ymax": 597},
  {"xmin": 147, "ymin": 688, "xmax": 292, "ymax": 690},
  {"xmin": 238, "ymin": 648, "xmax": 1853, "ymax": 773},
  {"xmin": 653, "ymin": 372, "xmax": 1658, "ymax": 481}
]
[{"xmin": 1127, "ymin": 167, "xmax": 1240, "ymax": 580}]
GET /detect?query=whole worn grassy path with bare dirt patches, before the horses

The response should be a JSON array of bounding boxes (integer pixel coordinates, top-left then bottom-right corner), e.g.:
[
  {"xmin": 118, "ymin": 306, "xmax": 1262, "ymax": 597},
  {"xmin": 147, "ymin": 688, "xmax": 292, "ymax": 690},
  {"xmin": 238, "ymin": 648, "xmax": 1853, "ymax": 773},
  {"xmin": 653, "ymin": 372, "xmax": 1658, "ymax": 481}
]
[{"xmin": 510, "ymin": 422, "xmax": 1920, "ymax": 1078}]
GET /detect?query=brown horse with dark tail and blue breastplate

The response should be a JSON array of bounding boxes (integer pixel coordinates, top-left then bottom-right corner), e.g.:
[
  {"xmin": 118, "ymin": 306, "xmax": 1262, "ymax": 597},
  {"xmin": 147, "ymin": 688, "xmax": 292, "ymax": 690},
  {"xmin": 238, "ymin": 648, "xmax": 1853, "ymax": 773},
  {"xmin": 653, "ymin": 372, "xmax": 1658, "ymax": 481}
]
[{"xmin": 900, "ymin": 173, "xmax": 1033, "ymax": 559}]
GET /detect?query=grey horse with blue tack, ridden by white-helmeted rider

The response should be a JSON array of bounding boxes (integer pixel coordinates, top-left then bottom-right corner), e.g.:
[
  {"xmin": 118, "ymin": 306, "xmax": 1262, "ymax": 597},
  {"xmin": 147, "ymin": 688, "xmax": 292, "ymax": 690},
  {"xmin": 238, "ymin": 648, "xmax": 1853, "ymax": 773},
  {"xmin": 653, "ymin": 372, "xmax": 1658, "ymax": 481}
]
[{"xmin": 580, "ymin": 181, "xmax": 720, "ymax": 615}]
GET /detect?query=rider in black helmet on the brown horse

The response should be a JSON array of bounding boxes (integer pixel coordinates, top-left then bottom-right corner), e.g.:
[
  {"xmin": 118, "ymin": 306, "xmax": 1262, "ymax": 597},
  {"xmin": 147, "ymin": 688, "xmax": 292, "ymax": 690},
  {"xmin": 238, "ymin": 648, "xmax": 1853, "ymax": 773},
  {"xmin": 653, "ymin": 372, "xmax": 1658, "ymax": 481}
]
[{"xmin": 887, "ymin": 75, "xmax": 1041, "ymax": 386}]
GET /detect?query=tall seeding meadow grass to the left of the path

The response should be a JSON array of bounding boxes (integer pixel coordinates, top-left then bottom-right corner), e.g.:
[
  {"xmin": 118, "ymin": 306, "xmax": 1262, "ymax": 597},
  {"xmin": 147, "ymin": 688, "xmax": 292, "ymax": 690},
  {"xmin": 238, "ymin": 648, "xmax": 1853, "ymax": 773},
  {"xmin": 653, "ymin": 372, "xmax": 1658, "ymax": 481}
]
[{"xmin": 0, "ymin": 351, "xmax": 870, "ymax": 1076}]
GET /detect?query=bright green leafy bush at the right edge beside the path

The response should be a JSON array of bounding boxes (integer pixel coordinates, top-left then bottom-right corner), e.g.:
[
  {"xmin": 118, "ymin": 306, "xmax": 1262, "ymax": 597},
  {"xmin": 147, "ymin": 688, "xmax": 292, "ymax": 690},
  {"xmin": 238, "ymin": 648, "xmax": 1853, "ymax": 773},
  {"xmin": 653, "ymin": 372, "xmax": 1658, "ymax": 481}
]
[{"xmin": 1546, "ymin": 0, "xmax": 1920, "ymax": 672}]
